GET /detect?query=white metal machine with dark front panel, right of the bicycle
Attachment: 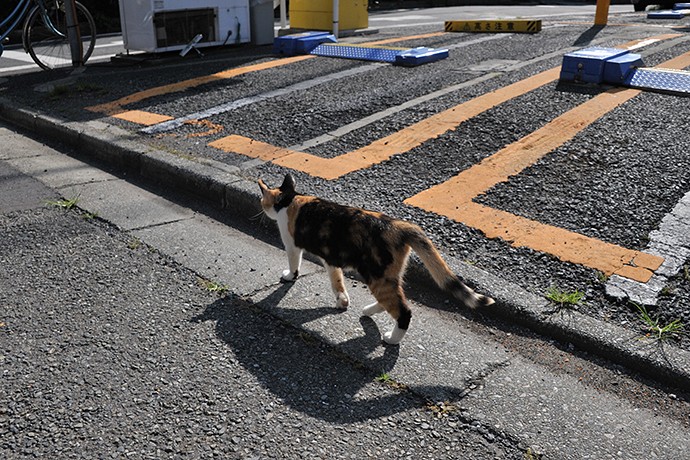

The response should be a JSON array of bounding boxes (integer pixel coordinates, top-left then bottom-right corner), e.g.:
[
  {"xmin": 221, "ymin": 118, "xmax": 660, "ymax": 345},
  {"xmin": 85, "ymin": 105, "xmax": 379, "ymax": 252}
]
[{"xmin": 120, "ymin": 0, "xmax": 251, "ymax": 53}]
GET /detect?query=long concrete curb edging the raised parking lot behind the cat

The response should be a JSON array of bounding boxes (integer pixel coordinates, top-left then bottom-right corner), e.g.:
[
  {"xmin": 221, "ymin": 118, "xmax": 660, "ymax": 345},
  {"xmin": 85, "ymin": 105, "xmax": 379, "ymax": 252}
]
[{"xmin": 0, "ymin": 98, "xmax": 690, "ymax": 388}]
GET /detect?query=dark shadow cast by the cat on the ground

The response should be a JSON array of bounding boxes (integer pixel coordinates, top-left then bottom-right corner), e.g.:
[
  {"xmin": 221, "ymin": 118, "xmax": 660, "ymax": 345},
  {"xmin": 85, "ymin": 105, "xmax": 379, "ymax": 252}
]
[{"xmin": 192, "ymin": 285, "xmax": 462, "ymax": 423}]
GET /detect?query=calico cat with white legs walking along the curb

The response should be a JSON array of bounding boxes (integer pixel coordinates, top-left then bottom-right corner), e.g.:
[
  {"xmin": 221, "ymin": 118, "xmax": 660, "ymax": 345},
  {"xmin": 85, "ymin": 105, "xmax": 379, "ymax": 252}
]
[{"xmin": 259, "ymin": 174, "xmax": 494, "ymax": 345}]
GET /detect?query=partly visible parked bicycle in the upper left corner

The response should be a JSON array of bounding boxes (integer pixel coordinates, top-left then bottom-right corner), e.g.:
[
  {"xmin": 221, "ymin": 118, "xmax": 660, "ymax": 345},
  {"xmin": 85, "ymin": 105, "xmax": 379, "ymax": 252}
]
[{"xmin": 0, "ymin": 0, "xmax": 96, "ymax": 70}]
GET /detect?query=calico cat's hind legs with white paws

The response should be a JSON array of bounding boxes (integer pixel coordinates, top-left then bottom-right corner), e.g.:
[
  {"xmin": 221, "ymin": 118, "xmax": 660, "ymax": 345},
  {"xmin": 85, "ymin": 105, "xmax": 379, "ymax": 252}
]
[{"xmin": 367, "ymin": 280, "xmax": 412, "ymax": 345}]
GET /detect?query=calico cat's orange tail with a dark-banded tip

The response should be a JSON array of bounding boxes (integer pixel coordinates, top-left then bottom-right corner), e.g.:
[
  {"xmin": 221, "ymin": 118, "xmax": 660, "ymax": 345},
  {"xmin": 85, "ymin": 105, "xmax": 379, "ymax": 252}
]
[{"xmin": 405, "ymin": 224, "xmax": 494, "ymax": 308}]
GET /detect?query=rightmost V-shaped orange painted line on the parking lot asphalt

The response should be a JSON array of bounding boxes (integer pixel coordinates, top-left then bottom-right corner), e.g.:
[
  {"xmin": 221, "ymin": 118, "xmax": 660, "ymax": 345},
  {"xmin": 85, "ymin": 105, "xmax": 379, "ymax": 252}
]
[{"xmin": 405, "ymin": 53, "xmax": 690, "ymax": 282}]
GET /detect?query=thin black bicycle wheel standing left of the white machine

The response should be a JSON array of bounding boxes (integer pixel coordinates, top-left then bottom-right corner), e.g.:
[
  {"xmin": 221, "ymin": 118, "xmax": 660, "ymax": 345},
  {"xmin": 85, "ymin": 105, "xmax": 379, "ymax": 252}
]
[{"xmin": 23, "ymin": 0, "xmax": 96, "ymax": 70}]
